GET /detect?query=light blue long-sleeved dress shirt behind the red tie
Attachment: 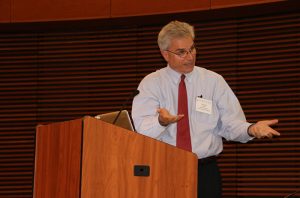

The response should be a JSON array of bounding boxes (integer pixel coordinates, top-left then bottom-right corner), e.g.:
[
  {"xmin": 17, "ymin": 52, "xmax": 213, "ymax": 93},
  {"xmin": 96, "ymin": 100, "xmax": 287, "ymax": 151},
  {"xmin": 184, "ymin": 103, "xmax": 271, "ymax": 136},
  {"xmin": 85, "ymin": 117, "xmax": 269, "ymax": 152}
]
[{"xmin": 132, "ymin": 66, "xmax": 252, "ymax": 158}]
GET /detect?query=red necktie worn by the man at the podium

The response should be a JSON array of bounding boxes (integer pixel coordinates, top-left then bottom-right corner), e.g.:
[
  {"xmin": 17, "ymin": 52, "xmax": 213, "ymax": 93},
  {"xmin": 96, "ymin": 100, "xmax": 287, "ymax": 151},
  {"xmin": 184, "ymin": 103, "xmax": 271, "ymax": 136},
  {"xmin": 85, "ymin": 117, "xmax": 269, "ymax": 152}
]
[{"xmin": 176, "ymin": 75, "xmax": 192, "ymax": 151}]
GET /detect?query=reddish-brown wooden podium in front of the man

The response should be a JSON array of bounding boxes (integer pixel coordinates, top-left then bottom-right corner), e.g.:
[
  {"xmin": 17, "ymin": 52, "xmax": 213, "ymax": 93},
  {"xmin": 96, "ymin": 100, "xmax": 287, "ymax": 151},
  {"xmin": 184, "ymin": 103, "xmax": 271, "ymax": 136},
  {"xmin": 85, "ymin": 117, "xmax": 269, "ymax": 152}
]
[{"xmin": 34, "ymin": 116, "xmax": 197, "ymax": 198}]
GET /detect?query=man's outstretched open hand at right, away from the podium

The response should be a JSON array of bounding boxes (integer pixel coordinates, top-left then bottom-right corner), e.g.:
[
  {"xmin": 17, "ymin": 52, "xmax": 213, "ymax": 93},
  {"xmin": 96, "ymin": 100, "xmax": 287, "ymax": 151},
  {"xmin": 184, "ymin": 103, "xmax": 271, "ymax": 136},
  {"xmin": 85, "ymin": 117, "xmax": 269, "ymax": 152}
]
[{"xmin": 248, "ymin": 119, "xmax": 280, "ymax": 139}]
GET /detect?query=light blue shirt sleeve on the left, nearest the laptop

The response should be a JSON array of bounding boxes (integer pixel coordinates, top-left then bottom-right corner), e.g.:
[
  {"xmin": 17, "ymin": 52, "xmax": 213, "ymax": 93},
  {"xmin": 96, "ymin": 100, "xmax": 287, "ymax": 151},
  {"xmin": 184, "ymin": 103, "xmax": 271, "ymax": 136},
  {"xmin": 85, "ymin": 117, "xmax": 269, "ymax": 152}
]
[{"xmin": 131, "ymin": 77, "xmax": 166, "ymax": 139}]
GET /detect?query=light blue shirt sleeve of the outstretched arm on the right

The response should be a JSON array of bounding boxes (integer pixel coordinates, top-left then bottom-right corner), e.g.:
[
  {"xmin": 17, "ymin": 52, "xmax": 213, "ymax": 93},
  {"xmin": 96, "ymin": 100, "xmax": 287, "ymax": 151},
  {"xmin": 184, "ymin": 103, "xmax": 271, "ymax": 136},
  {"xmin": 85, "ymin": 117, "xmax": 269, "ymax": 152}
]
[{"xmin": 215, "ymin": 76, "xmax": 253, "ymax": 143}]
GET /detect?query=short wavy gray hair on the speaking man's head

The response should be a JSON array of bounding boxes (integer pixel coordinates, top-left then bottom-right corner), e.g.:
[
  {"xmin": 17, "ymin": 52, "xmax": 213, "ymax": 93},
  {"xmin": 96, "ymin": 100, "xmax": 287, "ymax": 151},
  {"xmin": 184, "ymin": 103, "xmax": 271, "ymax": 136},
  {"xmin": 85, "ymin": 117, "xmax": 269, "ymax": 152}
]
[{"xmin": 157, "ymin": 21, "xmax": 195, "ymax": 50}]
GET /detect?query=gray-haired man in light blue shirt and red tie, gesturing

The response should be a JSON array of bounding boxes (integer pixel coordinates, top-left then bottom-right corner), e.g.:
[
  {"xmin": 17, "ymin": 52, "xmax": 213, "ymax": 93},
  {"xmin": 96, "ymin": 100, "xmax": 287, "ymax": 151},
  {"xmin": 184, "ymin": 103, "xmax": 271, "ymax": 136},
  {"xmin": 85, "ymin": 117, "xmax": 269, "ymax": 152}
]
[{"xmin": 132, "ymin": 21, "xmax": 280, "ymax": 198}]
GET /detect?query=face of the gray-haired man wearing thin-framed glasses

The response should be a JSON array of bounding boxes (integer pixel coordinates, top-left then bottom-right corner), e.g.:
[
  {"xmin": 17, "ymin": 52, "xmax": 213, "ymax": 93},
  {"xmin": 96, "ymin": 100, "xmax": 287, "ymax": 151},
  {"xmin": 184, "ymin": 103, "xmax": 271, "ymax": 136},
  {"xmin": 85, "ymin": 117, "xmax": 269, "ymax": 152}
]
[{"xmin": 161, "ymin": 37, "xmax": 196, "ymax": 74}]
